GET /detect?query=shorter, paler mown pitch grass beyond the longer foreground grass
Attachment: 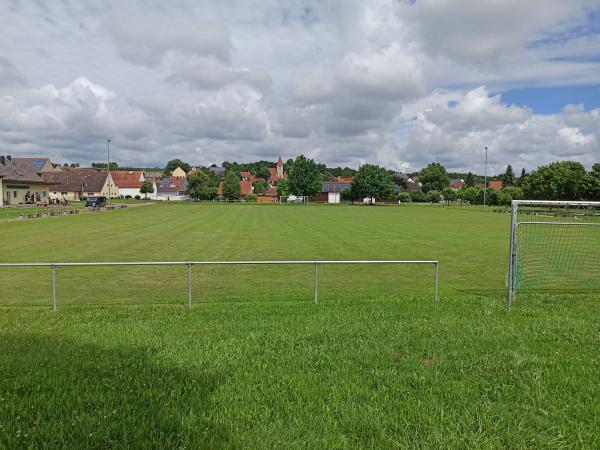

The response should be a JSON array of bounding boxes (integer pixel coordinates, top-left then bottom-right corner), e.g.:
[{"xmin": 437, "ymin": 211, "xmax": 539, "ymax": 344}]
[{"xmin": 0, "ymin": 203, "xmax": 508, "ymax": 305}]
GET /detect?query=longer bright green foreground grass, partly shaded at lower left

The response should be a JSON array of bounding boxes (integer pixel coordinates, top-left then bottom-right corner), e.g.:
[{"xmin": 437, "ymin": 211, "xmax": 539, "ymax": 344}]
[{"xmin": 0, "ymin": 296, "xmax": 600, "ymax": 448}]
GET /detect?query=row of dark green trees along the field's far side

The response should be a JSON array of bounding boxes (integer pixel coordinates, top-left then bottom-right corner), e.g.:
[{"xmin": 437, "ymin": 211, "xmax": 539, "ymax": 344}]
[{"xmin": 178, "ymin": 155, "xmax": 600, "ymax": 205}]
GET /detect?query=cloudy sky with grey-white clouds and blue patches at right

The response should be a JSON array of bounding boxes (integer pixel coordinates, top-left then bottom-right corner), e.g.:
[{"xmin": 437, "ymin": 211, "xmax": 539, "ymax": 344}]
[{"xmin": 0, "ymin": 0, "xmax": 600, "ymax": 172}]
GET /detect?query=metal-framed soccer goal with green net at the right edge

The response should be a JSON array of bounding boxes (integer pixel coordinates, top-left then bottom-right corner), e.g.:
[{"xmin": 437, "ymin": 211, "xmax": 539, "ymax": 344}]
[{"xmin": 508, "ymin": 200, "xmax": 600, "ymax": 308}]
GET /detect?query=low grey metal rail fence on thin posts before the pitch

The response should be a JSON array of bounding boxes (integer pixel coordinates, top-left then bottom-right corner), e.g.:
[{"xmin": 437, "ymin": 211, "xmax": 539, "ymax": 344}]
[{"xmin": 0, "ymin": 260, "xmax": 439, "ymax": 312}]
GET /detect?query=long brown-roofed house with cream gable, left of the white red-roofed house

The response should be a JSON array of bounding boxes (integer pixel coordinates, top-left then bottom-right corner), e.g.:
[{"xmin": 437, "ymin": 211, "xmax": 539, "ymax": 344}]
[{"xmin": 42, "ymin": 167, "xmax": 119, "ymax": 201}]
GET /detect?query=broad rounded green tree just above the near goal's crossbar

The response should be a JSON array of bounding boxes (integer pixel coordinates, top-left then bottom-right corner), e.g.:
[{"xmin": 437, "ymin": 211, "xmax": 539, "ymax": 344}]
[{"xmin": 522, "ymin": 161, "xmax": 589, "ymax": 200}]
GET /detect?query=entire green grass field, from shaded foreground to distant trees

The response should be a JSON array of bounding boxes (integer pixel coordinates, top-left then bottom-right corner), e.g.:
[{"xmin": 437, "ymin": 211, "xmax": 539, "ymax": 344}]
[{"xmin": 0, "ymin": 204, "xmax": 600, "ymax": 448}]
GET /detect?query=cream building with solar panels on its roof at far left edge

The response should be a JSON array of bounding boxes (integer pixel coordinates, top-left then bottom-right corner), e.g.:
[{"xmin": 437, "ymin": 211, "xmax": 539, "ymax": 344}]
[{"xmin": 0, "ymin": 156, "xmax": 51, "ymax": 207}]
